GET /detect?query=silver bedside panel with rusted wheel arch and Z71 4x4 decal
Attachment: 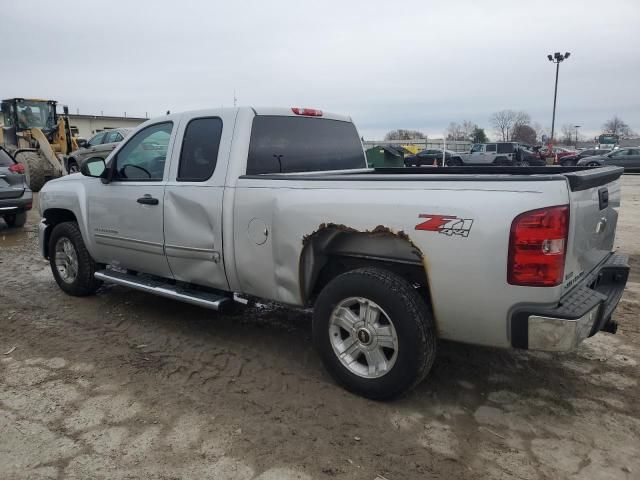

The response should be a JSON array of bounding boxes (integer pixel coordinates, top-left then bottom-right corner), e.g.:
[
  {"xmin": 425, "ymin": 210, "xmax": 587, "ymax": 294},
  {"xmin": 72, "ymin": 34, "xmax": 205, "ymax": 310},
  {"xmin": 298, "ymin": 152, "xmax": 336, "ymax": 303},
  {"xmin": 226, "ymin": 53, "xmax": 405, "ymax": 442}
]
[{"xmin": 231, "ymin": 179, "xmax": 569, "ymax": 347}]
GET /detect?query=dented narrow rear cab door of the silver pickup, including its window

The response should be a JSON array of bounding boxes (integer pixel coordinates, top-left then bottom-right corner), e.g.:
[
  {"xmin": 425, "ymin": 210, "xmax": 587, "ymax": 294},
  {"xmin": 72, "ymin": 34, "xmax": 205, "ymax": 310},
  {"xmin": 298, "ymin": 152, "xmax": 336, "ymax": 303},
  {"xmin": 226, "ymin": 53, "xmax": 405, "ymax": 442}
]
[{"xmin": 164, "ymin": 110, "xmax": 236, "ymax": 290}]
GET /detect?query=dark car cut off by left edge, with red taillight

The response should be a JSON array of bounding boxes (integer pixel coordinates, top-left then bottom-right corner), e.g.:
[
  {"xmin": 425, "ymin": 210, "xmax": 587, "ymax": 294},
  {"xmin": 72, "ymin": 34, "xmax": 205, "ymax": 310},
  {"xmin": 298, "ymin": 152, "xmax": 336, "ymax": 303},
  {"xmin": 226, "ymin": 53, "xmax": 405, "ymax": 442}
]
[{"xmin": 0, "ymin": 147, "xmax": 33, "ymax": 227}]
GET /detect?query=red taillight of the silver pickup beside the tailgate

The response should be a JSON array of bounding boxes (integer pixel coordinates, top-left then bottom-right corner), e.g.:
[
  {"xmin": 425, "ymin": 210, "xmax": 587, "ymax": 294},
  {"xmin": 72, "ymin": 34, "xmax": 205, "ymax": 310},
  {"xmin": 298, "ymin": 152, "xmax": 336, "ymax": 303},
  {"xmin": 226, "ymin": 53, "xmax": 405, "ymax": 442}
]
[{"xmin": 507, "ymin": 205, "xmax": 569, "ymax": 287}]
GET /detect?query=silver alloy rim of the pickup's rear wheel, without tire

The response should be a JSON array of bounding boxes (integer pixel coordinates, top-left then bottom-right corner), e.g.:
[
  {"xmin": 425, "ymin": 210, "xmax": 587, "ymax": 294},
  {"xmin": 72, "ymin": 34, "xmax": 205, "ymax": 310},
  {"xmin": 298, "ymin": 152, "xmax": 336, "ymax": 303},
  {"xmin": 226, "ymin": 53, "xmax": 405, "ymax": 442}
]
[{"xmin": 329, "ymin": 297, "xmax": 399, "ymax": 378}]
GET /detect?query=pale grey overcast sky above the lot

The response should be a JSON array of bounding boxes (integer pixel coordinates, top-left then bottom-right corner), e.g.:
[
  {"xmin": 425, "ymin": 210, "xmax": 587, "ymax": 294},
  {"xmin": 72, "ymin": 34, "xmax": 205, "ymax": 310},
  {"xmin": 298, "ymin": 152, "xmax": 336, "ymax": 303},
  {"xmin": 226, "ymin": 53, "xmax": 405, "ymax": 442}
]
[{"xmin": 5, "ymin": 0, "xmax": 640, "ymax": 139}]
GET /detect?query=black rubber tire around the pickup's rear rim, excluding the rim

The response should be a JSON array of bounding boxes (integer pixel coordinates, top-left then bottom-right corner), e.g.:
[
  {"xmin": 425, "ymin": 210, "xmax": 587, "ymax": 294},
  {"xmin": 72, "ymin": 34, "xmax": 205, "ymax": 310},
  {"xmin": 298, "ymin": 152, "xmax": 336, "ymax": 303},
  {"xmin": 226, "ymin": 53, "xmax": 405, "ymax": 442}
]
[{"xmin": 313, "ymin": 268, "xmax": 437, "ymax": 400}]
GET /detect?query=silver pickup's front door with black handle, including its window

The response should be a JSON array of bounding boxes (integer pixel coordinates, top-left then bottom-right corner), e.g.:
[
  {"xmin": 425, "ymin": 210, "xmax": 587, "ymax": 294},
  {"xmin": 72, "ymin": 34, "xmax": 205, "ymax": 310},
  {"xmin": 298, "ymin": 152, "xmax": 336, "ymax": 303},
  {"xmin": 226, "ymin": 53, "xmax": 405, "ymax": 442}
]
[{"xmin": 87, "ymin": 121, "xmax": 176, "ymax": 278}]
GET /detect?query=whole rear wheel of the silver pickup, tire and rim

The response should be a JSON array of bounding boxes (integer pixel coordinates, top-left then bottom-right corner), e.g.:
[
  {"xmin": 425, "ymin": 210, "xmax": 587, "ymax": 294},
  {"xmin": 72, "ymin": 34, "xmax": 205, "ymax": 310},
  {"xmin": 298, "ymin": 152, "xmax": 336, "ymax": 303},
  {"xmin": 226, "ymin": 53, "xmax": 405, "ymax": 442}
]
[{"xmin": 313, "ymin": 268, "xmax": 436, "ymax": 400}]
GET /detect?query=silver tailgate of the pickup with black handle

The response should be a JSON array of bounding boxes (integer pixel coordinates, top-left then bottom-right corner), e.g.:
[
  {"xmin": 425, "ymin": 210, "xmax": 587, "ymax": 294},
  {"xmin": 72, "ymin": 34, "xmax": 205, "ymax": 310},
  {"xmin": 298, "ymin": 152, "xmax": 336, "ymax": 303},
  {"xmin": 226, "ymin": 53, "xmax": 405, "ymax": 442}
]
[{"xmin": 564, "ymin": 167, "xmax": 623, "ymax": 289}]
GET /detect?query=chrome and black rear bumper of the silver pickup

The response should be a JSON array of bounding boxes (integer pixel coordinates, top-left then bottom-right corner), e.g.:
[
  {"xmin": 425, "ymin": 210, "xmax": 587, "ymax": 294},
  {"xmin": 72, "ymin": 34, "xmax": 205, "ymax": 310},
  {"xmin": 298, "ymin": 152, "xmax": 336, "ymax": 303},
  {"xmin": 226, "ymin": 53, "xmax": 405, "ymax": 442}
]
[{"xmin": 511, "ymin": 254, "xmax": 629, "ymax": 352}]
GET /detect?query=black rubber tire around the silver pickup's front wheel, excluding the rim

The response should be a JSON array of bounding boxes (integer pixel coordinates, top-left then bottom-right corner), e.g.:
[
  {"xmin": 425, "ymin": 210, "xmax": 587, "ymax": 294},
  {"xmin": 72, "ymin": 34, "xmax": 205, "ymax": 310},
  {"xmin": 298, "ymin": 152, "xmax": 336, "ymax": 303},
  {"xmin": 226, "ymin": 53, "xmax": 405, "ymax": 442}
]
[{"xmin": 49, "ymin": 222, "xmax": 102, "ymax": 297}]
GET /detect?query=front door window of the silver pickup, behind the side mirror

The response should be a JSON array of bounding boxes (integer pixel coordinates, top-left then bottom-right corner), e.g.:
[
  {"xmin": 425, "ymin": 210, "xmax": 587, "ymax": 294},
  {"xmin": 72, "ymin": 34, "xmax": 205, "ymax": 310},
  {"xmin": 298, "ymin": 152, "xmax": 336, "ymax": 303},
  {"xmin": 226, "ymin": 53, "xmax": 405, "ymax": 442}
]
[{"xmin": 114, "ymin": 122, "xmax": 173, "ymax": 181}]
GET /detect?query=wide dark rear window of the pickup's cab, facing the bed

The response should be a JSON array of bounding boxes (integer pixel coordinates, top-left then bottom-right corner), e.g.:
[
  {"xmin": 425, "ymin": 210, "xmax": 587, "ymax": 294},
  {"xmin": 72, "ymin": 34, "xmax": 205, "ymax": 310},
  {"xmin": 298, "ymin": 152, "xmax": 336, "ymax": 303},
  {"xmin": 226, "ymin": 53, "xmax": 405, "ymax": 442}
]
[{"xmin": 247, "ymin": 115, "xmax": 367, "ymax": 175}]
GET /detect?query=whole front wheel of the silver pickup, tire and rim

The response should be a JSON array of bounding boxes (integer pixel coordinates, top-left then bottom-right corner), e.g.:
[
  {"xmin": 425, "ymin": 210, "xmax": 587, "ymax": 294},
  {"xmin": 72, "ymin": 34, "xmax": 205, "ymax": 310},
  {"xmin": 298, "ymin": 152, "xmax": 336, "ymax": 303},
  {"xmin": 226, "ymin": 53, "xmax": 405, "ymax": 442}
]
[{"xmin": 49, "ymin": 222, "xmax": 102, "ymax": 297}]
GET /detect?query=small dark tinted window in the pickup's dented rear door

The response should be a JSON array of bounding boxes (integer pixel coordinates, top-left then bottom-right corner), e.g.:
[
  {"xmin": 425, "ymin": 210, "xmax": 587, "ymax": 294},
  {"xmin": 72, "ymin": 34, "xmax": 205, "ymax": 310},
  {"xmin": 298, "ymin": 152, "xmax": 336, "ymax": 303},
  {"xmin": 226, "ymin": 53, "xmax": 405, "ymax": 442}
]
[{"xmin": 177, "ymin": 118, "xmax": 222, "ymax": 182}]
